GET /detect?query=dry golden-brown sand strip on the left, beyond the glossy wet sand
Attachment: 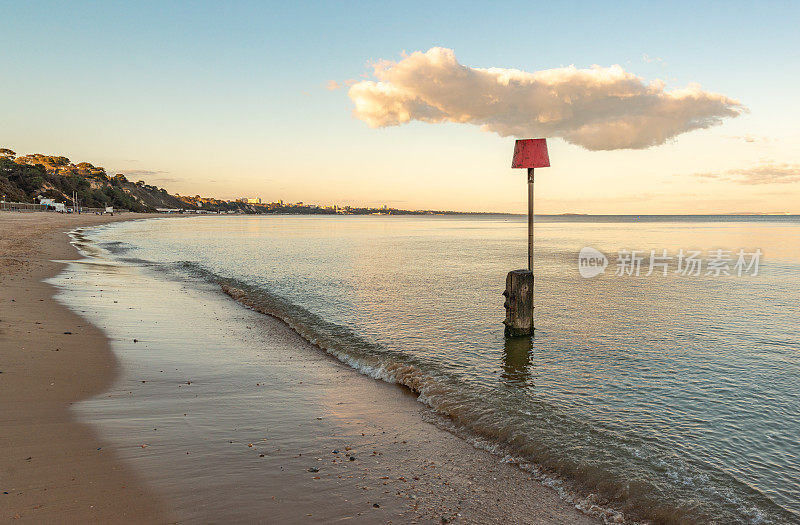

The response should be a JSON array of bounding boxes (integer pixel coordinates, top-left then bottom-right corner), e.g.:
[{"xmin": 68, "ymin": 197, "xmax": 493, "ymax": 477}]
[{"xmin": 0, "ymin": 212, "xmax": 169, "ymax": 523}]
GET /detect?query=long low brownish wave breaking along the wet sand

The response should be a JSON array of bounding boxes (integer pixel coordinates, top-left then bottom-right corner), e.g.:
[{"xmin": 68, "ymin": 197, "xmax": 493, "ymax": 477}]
[{"xmin": 209, "ymin": 278, "xmax": 790, "ymax": 523}]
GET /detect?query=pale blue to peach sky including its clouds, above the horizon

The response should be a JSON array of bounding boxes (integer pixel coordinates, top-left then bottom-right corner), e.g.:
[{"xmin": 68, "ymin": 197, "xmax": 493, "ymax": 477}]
[{"xmin": 0, "ymin": 1, "xmax": 800, "ymax": 214}]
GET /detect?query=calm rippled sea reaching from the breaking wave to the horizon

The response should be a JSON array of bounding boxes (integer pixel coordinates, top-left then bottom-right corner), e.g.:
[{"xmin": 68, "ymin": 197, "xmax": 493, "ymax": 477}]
[{"xmin": 89, "ymin": 216, "xmax": 800, "ymax": 523}]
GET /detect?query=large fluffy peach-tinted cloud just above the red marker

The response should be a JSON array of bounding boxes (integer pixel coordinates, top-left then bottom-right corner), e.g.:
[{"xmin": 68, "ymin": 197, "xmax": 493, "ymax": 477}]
[{"xmin": 349, "ymin": 47, "xmax": 745, "ymax": 150}]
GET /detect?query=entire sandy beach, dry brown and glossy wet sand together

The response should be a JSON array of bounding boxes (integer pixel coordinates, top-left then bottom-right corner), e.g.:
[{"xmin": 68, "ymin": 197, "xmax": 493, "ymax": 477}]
[{"xmin": 0, "ymin": 214, "xmax": 596, "ymax": 523}]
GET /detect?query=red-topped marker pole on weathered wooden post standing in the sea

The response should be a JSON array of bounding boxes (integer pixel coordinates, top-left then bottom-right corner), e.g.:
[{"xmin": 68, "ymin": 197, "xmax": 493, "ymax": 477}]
[{"xmin": 503, "ymin": 139, "xmax": 550, "ymax": 337}]
